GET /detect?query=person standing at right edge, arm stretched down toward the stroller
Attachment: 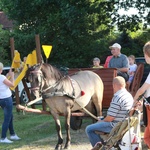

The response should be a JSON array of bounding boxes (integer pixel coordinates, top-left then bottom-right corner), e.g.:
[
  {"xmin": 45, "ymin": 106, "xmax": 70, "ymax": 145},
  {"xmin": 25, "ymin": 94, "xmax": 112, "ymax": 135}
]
[{"xmin": 134, "ymin": 41, "xmax": 150, "ymax": 148}]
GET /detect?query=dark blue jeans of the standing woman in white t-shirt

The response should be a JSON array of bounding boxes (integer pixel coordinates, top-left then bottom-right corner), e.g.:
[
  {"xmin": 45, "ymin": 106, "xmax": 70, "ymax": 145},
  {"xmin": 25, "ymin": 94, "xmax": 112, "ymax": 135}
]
[{"xmin": 0, "ymin": 97, "xmax": 15, "ymax": 139}]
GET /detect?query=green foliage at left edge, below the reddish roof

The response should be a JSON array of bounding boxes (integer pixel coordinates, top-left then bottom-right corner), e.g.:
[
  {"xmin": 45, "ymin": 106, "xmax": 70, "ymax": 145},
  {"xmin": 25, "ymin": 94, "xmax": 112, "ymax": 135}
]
[{"xmin": 0, "ymin": 26, "xmax": 11, "ymax": 66}]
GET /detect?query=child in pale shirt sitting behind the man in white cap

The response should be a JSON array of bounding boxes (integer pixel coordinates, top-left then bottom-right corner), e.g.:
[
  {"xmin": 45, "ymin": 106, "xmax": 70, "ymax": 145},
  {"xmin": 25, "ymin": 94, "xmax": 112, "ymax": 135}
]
[{"xmin": 127, "ymin": 55, "xmax": 137, "ymax": 87}]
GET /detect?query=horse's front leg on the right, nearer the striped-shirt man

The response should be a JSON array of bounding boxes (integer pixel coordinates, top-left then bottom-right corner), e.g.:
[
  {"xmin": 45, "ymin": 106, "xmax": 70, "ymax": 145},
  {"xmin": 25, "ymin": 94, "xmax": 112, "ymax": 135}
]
[{"xmin": 64, "ymin": 107, "xmax": 71, "ymax": 149}]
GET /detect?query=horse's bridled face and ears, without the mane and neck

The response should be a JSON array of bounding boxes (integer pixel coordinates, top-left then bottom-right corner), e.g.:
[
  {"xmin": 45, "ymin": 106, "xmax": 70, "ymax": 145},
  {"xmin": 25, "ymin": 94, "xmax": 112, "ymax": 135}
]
[{"xmin": 25, "ymin": 64, "xmax": 44, "ymax": 99}]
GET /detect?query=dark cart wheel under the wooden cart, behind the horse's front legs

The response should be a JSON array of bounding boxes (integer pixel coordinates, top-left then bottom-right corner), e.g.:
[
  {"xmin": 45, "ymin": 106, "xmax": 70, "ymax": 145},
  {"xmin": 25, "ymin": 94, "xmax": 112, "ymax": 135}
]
[{"xmin": 70, "ymin": 116, "xmax": 82, "ymax": 130}]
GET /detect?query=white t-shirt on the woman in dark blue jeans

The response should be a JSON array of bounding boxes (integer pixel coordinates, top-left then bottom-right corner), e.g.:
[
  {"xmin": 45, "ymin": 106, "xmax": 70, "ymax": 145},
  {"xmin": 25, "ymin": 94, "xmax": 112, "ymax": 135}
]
[{"xmin": 0, "ymin": 74, "xmax": 12, "ymax": 99}]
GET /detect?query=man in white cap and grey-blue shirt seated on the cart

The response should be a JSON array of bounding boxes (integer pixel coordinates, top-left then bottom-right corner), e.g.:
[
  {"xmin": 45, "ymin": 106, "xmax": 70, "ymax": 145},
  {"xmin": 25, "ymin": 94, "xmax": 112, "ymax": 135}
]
[{"xmin": 109, "ymin": 43, "xmax": 129, "ymax": 81}]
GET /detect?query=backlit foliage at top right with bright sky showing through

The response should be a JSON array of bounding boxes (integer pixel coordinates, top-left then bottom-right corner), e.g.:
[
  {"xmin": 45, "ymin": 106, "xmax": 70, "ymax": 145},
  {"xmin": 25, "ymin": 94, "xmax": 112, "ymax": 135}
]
[{"xmin": 111, "ymin": 0, "xmax": 150, "ymax": 31}]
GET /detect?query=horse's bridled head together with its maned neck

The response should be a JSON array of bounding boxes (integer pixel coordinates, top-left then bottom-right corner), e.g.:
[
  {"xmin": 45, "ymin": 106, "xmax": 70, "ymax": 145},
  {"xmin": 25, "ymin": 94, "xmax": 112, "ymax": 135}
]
[{"xmin": 25, "ymin": 63, "xmax": 63, "ymax": 98}]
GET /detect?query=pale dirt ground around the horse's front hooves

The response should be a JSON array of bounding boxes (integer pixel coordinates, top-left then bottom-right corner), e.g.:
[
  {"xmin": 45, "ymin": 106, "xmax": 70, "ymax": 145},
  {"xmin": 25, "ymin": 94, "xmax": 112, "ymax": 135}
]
[{"xmin": 13, "ymin": 123, "xmax": 147, "ymax": 150}]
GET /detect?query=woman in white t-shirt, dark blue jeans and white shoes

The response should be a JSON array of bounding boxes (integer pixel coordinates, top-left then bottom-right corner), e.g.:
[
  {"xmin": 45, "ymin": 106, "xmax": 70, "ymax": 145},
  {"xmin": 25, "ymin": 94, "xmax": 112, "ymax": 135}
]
[{"xmin": 0, "ymin": 62, "xmax": 20, "ymax": 143}]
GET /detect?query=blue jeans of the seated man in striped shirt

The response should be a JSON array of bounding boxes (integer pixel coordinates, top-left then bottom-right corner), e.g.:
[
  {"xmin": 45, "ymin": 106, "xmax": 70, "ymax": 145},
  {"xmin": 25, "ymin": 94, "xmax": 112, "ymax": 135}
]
[{"xmin": 85, "ymin": 121, "xmax": 113, "ymax": 147}]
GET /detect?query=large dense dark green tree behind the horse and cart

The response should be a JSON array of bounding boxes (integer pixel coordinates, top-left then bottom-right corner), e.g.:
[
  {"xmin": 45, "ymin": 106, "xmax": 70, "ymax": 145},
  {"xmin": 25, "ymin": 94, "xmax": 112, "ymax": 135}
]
[{"xmin": 1, "ymin": 0, "xmax": 115, "ymax": 67}]
